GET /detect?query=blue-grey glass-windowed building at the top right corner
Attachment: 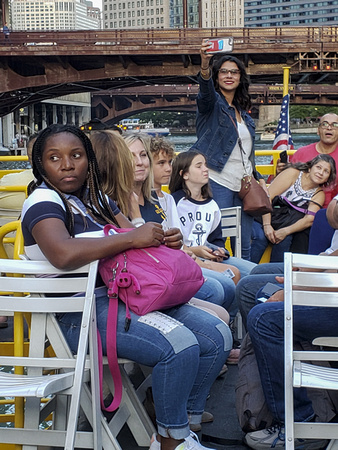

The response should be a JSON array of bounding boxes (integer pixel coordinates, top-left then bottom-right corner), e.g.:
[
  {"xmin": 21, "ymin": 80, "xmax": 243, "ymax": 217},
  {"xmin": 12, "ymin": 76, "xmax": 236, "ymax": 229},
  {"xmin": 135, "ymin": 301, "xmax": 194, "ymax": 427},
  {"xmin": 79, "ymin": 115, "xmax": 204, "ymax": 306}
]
[{"xmin": 244, "ymin": 0, "xmax": 338, "ymax": 27}]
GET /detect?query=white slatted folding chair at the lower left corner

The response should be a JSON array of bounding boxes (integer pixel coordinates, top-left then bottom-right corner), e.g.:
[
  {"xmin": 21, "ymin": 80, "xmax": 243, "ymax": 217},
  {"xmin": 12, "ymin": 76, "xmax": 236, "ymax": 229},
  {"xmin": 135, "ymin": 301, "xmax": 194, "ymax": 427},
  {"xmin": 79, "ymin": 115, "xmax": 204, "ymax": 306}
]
[{"xmin": 0, "ymin": 259, "xmax": 101, "ymax": 450}]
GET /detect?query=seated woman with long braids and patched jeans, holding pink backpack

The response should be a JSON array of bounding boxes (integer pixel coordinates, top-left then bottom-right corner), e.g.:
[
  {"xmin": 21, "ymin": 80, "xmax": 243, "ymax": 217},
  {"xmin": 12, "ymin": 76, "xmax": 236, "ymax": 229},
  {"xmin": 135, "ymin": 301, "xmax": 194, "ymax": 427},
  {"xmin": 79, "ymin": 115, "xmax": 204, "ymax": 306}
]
[{"xmin": 22, "ymin": 125, "xmax": 232, "ymax": 450}]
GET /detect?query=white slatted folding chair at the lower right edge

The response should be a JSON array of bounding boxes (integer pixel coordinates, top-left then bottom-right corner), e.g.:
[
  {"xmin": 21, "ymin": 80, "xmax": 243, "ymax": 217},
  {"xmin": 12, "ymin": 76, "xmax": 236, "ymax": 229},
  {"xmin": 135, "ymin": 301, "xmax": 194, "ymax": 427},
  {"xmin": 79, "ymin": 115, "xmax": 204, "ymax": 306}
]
[{"xmin": 284, "ymin": 253, "xmax": 338, "ymax": 450}]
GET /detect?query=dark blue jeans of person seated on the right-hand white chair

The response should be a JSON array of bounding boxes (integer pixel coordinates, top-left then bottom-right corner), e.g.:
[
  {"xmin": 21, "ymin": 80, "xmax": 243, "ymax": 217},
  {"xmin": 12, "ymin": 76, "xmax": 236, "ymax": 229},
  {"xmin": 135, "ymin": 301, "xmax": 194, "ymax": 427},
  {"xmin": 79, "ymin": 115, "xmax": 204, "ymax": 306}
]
[{"xmin": 247, "ymin": 302, "xmax": 338, "ymax": 422}]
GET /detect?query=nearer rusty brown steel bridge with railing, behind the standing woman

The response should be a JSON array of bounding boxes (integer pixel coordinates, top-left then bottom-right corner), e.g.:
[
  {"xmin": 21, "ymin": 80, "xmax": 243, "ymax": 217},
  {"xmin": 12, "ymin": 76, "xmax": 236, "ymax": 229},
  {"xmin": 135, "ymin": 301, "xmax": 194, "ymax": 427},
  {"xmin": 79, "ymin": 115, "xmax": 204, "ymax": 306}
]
[{"xmin": 0, "ymin": 26, "xmax": 338, "ymax": 116}]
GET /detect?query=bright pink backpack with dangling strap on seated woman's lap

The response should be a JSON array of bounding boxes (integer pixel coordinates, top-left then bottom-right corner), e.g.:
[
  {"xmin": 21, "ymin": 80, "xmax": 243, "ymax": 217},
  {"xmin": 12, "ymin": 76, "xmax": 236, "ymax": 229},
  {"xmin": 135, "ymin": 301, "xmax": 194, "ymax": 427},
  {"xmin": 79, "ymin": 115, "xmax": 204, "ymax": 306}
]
[{"xmin": 99, "ymin": 225, "xmax": 204, "ymax": 411}]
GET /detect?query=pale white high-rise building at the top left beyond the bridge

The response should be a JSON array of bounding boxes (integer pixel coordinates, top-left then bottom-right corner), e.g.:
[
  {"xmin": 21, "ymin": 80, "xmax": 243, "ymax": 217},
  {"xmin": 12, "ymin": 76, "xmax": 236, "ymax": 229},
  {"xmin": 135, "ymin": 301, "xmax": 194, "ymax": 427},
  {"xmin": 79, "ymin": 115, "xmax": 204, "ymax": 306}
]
[{"xmin": 11, "ymin": 0, "xmax": 101, "ymax": 31}]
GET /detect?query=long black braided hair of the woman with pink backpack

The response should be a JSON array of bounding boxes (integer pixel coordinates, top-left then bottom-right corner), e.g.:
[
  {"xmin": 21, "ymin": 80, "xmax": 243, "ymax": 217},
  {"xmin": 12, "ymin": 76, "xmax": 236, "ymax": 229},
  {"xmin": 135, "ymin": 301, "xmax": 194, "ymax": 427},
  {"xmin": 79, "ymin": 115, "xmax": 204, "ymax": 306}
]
[{"xmin": 28, "ymin": 124, "xmax": 118, "ymax": 237}]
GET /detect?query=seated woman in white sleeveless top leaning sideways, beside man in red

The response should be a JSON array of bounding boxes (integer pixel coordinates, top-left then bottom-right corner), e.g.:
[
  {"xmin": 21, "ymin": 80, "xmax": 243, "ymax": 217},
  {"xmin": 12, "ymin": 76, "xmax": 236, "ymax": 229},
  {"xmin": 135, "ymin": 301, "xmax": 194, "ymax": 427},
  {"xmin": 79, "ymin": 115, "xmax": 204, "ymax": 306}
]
[{"xmin": 252, "ymin": 154, "xmax": 336, "ymax": 262}]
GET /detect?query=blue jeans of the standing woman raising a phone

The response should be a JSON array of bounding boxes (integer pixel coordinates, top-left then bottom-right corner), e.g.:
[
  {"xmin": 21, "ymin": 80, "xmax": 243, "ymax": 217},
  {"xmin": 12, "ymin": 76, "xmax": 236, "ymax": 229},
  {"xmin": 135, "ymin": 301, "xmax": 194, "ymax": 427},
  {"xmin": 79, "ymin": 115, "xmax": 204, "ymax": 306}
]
[{"xmin": 210, "ymin": 180, "xmax": 253, "ymax": 261}]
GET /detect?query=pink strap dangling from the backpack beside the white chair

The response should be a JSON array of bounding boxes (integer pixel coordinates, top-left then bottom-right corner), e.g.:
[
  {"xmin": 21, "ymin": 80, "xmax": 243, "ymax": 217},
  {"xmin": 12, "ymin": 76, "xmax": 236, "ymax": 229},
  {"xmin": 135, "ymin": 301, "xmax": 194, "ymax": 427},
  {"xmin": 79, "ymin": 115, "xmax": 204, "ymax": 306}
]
[{"xmin": 97, "ymin": 298, "xmax": 122, "ymax": 412}]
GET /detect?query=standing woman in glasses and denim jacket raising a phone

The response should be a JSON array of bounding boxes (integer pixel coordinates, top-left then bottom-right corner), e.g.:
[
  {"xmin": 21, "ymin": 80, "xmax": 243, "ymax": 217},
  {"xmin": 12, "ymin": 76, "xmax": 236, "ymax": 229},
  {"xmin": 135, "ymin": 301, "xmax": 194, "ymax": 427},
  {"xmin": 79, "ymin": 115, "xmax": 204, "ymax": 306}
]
[{"xmin": 193, "ymin": 39, "xmax": 264, "ymax": 260}]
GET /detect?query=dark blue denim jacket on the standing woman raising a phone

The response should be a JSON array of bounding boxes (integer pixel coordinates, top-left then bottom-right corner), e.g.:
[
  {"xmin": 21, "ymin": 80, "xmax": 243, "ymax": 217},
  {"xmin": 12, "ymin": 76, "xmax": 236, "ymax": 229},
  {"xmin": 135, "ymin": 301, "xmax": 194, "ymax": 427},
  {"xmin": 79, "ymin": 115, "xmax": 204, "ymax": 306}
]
[{"xmin": 192, "ymin": 74, "xmax": 261, "ymax": 179}]
